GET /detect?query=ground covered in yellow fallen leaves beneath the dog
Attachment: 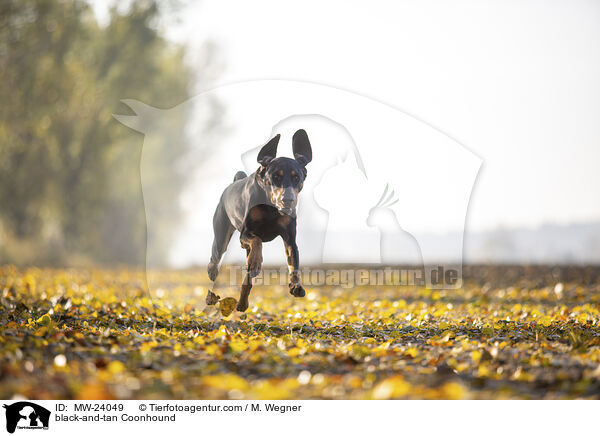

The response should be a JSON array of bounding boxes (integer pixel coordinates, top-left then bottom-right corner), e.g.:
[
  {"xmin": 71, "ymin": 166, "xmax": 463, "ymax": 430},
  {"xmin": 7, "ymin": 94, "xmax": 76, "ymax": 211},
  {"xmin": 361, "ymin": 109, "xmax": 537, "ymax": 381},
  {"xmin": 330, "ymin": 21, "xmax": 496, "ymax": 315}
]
[{"xmin": 0, "ymin": 267, "xmax": 600, "ymax": 399}]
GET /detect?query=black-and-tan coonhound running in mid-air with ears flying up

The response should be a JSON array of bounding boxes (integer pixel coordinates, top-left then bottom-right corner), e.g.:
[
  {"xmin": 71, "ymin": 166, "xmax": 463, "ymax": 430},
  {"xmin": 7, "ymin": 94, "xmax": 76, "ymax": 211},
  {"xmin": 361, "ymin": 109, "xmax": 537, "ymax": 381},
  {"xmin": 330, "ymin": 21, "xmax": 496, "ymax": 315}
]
[{"xmin": 206, "ymin": 129, "xmax": 312, "ymax": 312}]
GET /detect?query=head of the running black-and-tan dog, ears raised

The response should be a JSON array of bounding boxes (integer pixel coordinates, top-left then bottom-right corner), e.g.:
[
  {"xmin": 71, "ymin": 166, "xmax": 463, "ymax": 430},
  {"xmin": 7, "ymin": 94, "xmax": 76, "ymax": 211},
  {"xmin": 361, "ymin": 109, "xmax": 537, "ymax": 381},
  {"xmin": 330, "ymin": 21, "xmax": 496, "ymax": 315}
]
[{"xmin": 256, "ymin": 129, "xmax": 312, "ymax": 216}]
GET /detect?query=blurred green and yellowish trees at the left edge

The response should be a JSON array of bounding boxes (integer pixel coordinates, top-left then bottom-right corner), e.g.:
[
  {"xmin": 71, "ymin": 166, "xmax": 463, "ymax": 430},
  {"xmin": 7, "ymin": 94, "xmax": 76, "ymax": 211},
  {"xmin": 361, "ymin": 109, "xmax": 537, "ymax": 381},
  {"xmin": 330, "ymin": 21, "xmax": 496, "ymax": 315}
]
[{"xmin": 0, "ymin": 0, "xmax": 220, "ymax": 265}]
